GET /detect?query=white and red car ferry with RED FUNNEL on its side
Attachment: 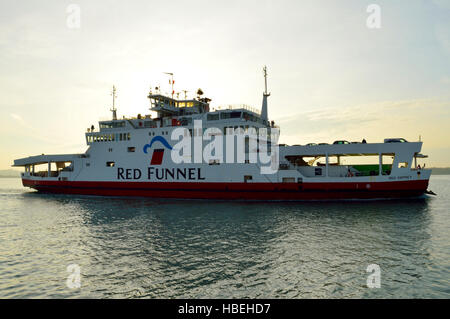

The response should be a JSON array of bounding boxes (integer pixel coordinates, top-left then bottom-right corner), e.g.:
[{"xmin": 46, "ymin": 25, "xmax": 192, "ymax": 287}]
[{"xmin": 13, "ymin": 67, "xmax": 431, "ymax": 201}]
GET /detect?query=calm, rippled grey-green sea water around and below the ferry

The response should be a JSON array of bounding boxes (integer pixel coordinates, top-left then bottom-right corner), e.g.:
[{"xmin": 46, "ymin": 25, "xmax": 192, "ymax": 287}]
[{"xmin": 0, "ymin": 176, "xmax": 450, "ymax": 298}]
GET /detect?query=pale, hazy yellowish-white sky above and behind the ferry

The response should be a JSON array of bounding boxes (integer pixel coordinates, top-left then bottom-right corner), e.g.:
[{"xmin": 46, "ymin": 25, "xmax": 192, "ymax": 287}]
[{"xmin": 0, "ymin": 0, "xmax": 450, "ymax": 169}]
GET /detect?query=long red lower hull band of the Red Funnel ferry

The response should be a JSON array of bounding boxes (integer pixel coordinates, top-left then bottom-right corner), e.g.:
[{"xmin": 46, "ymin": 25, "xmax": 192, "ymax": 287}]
[{"xmin": 22, "ymin": 179, "xmax": 428, "ymax": 200}]
